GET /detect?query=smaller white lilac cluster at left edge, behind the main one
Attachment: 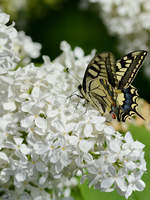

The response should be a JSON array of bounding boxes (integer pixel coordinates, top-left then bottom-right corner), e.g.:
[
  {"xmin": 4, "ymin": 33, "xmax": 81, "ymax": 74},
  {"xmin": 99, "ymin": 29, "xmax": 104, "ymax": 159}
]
[{"xmin": 0, "ymin": 10, "xmax": 41, "ymax": 74}]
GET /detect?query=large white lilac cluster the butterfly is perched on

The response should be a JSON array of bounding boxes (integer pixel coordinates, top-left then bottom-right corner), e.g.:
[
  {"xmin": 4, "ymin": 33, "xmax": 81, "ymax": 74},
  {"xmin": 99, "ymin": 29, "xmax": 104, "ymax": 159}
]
[{"xmin": 0, "ymin": 11, "xmax": 146, "ymax": 200}]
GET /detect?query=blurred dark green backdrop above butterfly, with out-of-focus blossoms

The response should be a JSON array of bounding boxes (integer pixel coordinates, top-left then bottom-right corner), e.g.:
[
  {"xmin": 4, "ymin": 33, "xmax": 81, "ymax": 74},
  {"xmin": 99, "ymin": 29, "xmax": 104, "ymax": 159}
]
[{"xmin": 0, "ymin": 0, "xmax": 150, "ymax": 102}]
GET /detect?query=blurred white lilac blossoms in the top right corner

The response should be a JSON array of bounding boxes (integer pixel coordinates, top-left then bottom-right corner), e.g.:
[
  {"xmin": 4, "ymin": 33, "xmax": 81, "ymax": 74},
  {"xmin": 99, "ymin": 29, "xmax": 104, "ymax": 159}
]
[{"xmin": 89, "ymin": 0, "xmax": 150, "ymax": 76}]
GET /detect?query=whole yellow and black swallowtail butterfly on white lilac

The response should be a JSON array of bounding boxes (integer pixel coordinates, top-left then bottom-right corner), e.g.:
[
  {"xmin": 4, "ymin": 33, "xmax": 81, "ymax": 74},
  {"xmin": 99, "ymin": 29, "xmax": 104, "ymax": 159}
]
[{"xmin": 78, "ymin": 50, "xmax": 147, "ymax": 121}]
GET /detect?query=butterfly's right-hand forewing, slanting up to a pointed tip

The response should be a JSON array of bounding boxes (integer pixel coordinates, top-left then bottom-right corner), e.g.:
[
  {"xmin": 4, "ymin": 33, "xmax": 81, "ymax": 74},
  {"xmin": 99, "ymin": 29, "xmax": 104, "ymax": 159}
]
[{"xmin": 116, "ymin": 50, "xmax": 147, "ymax": 89}]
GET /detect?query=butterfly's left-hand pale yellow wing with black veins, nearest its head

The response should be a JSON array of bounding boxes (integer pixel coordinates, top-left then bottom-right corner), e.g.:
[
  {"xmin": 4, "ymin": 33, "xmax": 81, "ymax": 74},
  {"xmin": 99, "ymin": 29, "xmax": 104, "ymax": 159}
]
[{"xmin": 78, "ymin": 52, "xmax": 116, "ymax": 113}]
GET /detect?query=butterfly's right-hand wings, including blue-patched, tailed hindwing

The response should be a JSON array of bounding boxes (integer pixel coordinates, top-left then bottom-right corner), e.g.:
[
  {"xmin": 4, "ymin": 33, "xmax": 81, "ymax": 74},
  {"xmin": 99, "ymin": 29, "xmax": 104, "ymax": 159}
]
[{"xmin": 114, "ymin": 50, "xmax": 147, "ymax": 121}]
